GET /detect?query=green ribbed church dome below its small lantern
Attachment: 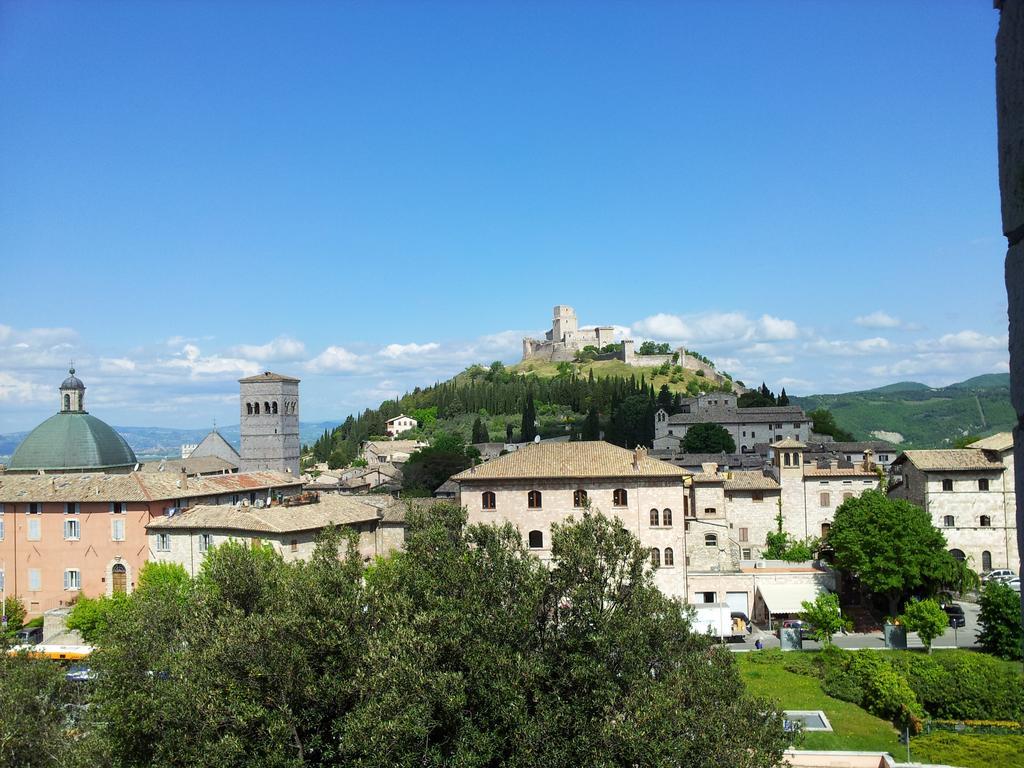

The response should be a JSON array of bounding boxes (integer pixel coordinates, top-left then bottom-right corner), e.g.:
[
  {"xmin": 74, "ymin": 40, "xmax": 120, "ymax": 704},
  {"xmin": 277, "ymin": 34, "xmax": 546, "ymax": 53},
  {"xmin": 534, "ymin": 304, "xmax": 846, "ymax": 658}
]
[{"xmin": 7, "ymin": 411, "xmax": 138, "ymax": 472}]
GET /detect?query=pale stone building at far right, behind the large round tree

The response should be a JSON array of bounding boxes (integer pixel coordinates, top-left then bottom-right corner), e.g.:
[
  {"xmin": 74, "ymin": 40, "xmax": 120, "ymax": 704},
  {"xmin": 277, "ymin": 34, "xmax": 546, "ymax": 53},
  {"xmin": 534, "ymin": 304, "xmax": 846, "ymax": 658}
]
[{"xmin": 889, "ymin": 432, "xmax": 1020, "ymax": 572}]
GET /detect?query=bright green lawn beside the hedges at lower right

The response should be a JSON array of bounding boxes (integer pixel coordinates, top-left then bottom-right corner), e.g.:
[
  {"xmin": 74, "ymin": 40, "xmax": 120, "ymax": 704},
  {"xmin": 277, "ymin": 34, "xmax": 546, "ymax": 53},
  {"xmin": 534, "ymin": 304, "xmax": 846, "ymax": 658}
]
[{"xmin": 736, "ymin": 653, "xmax": 1024, "ymax": 768}]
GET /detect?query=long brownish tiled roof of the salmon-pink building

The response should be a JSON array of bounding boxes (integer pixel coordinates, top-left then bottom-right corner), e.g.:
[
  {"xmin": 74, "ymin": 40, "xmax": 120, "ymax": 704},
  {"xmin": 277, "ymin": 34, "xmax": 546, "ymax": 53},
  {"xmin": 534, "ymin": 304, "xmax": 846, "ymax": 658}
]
[{"xmin": 0, "ymin": 472, "xmax": 302, "ymax": 502}]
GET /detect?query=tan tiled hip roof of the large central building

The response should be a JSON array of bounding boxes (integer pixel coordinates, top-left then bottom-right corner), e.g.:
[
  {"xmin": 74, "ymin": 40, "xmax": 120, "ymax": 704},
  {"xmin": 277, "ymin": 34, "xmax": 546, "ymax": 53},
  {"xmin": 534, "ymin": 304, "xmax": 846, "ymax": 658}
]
[{"xmin": 452, "ymin": 440, "xmax": 690, "ymax": 481}]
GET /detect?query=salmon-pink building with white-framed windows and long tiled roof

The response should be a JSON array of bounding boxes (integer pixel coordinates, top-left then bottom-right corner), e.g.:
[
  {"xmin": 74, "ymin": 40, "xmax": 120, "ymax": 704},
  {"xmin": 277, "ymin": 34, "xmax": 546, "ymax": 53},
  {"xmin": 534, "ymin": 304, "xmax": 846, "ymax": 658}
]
[{"xmin": 0, "ymin": 468, "xmax": 301, "ymax": 616}]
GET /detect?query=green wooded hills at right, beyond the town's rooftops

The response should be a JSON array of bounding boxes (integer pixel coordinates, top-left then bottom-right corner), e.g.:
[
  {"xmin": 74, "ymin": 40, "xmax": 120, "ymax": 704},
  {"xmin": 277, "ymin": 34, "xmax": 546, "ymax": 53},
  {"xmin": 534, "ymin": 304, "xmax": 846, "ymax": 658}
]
[{"xmin": 791, "ymin": 374, "xmax": 1016, "ymax": 447}]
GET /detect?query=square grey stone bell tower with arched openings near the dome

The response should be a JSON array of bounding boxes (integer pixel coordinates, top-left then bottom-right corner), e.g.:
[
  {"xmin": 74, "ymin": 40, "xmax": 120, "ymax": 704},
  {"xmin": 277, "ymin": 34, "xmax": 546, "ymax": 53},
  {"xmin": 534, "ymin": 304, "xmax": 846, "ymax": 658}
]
[{"xmin": 239, "ymin": 371, "xmax": 301, "ymax": 477}]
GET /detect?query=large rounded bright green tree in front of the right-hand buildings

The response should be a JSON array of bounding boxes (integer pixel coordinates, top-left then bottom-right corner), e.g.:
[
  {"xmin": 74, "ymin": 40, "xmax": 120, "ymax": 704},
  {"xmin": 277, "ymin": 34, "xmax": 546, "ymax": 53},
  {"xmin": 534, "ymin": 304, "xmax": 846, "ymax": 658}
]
[{"xmin": 828, "ymin": 490, "xmax": 952, "ymax": 616}]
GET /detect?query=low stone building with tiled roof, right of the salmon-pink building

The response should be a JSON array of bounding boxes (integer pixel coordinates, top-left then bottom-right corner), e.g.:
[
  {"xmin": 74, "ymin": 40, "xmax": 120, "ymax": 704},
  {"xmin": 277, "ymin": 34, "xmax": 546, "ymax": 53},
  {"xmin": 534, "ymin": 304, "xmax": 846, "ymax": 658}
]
[{"xmin": 146, "ymin": 494, "xmax": 406, "ymax": 575}]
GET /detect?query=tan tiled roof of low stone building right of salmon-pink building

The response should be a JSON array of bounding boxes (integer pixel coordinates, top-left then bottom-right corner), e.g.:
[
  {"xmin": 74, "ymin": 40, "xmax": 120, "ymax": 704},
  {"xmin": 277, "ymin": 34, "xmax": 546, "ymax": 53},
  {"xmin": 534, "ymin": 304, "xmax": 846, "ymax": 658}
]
[{"xmin": 145, "ymin": 494, "xmax": 381, "ymax": 534}]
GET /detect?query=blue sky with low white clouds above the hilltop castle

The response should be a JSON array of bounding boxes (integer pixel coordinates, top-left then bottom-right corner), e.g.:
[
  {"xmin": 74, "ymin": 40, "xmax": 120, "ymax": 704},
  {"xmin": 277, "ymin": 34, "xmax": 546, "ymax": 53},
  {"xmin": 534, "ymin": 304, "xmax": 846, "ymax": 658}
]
[{"xmin": 0, "ymin": 0, "xmax": 1008, "ymax": 432}]
